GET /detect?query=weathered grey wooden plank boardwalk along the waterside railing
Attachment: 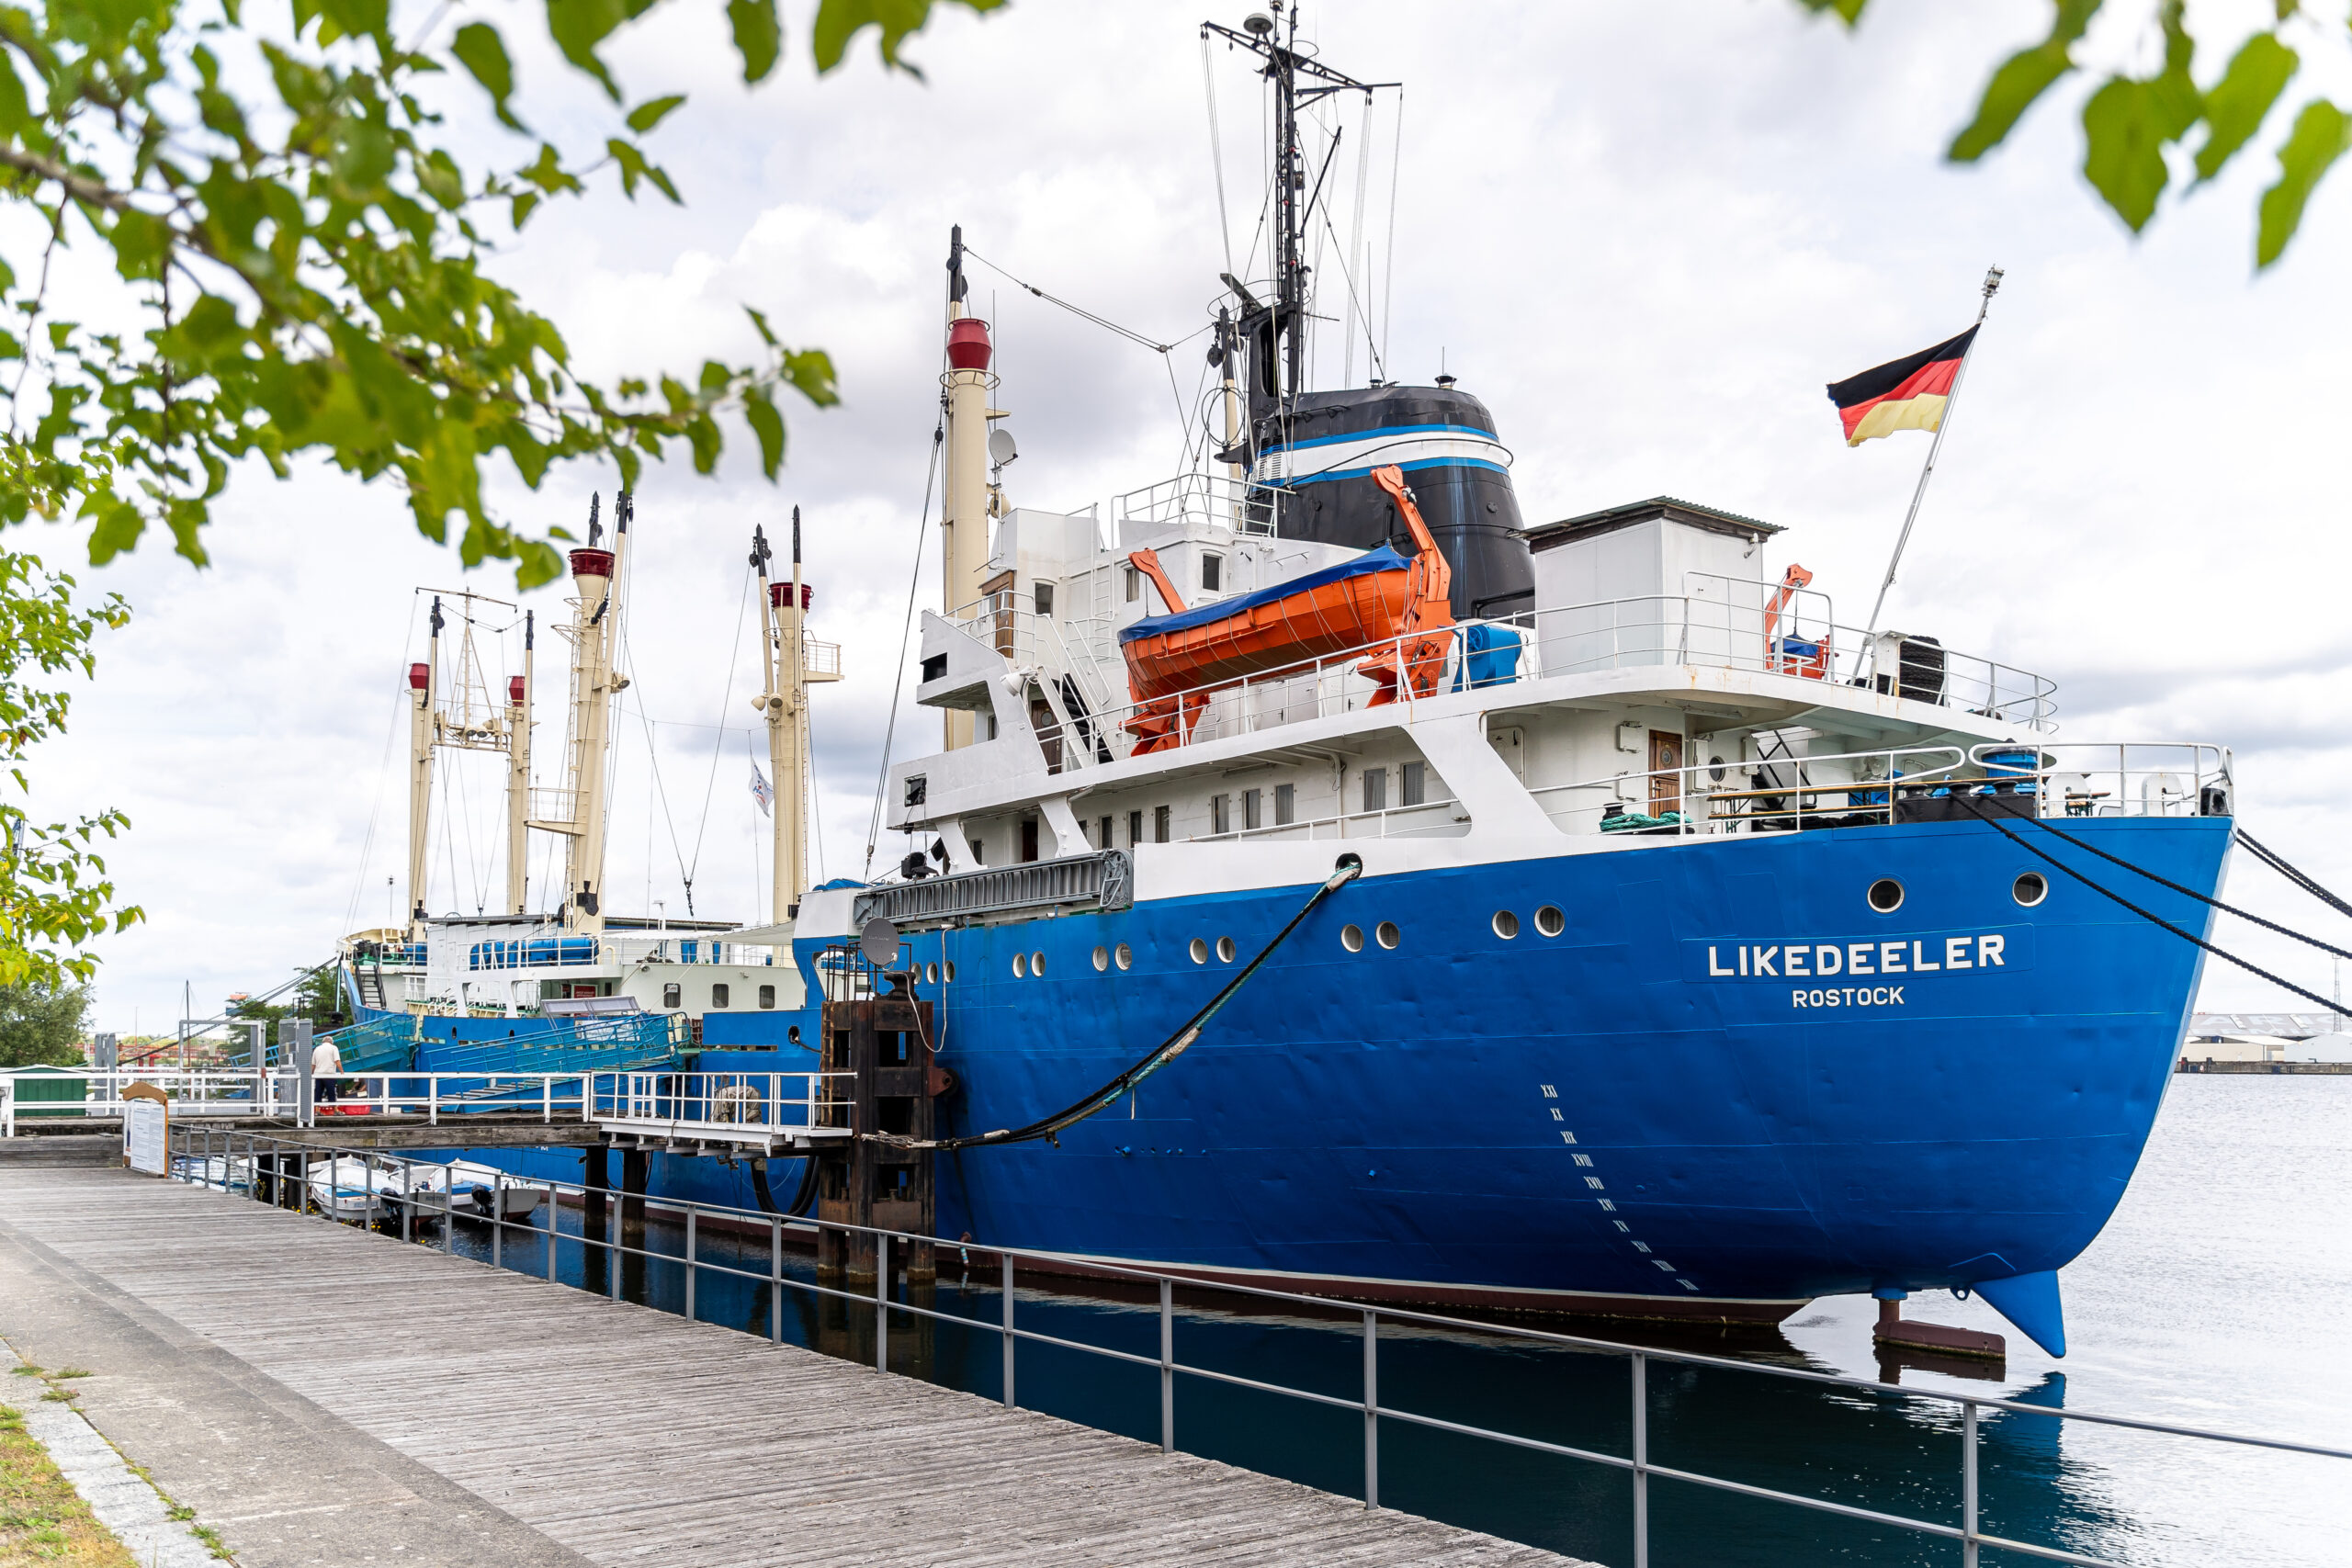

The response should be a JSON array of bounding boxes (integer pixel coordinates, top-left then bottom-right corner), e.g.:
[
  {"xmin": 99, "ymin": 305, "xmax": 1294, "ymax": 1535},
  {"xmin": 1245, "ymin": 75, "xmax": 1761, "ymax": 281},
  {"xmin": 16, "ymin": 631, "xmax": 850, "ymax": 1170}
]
[{"xmin": 0, "ymin": 1168, "xmax": 1569, "ymax": 1568}]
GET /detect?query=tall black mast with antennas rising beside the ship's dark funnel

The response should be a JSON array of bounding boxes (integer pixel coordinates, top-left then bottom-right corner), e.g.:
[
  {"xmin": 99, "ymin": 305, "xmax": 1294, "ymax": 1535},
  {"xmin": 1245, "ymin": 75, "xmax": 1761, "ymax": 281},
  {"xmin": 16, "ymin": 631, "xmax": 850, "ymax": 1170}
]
[{"xmin": 1200, "ymin": 0, "xmax": 1397, "ymax": 456}]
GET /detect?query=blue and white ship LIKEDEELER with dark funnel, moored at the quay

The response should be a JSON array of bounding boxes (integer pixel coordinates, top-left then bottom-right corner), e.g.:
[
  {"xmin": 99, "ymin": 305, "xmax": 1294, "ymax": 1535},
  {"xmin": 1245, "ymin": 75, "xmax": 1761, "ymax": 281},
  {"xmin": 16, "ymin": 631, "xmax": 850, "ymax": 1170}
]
[{"xmin": 331, "ymin": 7, "xmax": 2234, "ymax": 1354}]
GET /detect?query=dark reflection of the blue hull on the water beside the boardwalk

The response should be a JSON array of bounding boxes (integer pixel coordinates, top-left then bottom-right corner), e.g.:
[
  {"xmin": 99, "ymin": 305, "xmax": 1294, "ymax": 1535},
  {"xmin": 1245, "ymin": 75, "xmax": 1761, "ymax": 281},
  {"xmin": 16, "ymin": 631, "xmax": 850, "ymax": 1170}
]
[{"xmin": 400, "ymin": 1203, "xmax": 2201, "ymax": 1568}]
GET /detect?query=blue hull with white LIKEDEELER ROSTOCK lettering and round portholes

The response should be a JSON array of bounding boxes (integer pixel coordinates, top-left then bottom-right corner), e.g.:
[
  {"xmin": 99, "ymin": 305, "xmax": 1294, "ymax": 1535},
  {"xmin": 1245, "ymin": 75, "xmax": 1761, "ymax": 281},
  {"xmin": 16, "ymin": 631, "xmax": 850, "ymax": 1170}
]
[{"xmin": 400, "ymin": 818, "xmax": 2232, "ymax": 1321}]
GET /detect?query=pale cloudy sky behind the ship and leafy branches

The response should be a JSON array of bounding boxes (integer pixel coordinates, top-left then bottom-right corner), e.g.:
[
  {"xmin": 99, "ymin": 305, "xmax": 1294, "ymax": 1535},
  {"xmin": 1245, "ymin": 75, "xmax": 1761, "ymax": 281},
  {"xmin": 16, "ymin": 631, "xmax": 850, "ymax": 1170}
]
[{"xmin": 32, "ymin": 0, "xmax": 2352, "ymax": 1032}]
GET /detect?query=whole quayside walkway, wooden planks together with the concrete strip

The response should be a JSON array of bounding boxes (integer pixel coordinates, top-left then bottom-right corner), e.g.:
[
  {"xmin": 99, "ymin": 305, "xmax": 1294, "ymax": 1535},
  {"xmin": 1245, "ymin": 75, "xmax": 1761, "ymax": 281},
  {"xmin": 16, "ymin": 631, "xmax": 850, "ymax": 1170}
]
[{"xmin": 0, "ymin": 1168, "xmax": 1569, "ymax": 1568}]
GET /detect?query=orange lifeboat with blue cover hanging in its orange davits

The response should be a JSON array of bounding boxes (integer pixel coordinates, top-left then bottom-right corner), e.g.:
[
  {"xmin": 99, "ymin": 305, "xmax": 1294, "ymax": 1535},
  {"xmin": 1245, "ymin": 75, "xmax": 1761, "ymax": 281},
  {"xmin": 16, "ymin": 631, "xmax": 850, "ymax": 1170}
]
[{"xmin": 1120, "ymin": 468, "xmax": 1453, "ymax": 752}]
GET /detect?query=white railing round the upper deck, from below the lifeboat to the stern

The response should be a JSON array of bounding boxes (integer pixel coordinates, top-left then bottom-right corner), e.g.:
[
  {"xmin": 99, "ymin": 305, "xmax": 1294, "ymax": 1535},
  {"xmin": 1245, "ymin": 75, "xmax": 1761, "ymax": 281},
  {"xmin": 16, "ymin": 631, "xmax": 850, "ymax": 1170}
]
[{"xmin": 1077, "ymin": 594, "xmax": 2058, "ymax": 760}]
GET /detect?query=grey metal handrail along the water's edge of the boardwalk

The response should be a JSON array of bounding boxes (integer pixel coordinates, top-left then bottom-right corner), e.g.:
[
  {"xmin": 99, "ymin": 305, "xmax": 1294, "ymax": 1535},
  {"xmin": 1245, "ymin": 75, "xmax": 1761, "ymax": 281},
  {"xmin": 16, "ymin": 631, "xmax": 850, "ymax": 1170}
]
[{"xmin": 156, "ymin": 1128, "xmax": 2352, "ymax": 1568}]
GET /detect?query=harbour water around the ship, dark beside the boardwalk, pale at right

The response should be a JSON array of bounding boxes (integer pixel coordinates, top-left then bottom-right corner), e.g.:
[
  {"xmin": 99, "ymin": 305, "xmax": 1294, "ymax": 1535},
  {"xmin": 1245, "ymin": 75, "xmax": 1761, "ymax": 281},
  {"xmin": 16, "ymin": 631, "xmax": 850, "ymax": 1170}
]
[{"xmin": 427, "ymin": 1077, "xmax": 2352, "ymax": 1568}]
